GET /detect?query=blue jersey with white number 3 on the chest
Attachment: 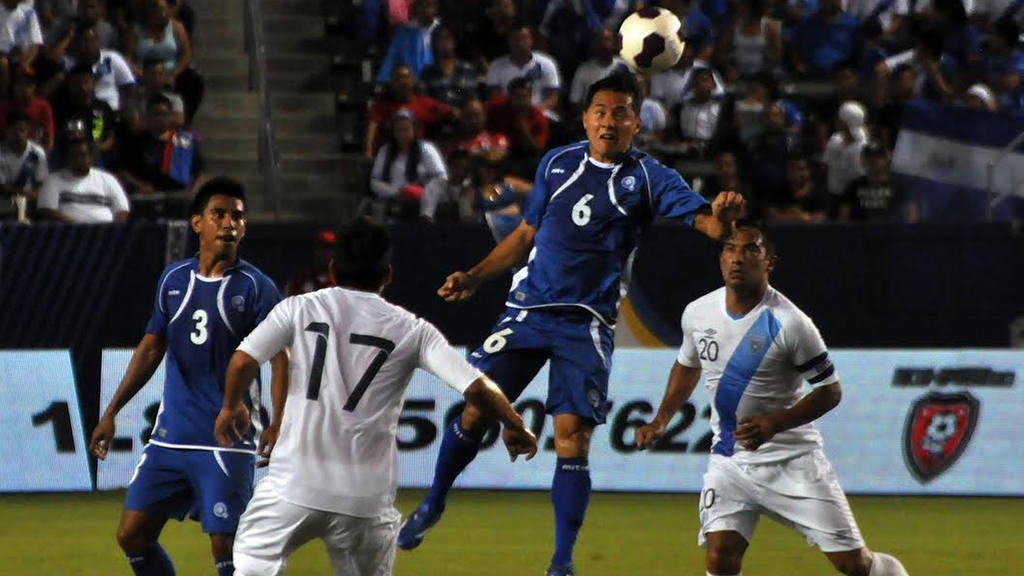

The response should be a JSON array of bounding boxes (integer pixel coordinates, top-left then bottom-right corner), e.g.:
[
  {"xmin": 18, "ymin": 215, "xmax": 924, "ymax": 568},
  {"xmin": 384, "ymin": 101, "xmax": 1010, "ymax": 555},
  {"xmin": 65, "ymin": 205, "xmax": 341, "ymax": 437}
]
[{"xmin": 145, "ymin": 257, "xmax": 281, "ymax": 451}]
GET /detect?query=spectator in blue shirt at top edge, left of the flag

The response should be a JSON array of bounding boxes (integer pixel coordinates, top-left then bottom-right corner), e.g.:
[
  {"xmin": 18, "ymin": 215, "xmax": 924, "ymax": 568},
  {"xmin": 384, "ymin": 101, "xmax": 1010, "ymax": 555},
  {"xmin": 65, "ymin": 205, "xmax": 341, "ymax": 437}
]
[{"xmin": 790, "ymin": 0, "xmax": 858, "ymax": 78}]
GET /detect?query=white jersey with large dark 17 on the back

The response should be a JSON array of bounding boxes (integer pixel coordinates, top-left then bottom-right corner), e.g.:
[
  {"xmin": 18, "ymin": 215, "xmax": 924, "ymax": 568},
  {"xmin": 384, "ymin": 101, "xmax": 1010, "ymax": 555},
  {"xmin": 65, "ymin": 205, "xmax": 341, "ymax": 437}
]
[{"xmin": 238, "ymin": 288, "xmax": 481, "ymax": 518}]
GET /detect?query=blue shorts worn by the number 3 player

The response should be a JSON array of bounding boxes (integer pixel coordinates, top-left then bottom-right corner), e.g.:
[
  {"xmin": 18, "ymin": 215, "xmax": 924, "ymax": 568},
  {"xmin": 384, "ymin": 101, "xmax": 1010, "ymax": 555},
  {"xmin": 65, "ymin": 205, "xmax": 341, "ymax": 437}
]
[{"xmin": 125, "ymin": 444, "xmax": 256, "ymax": 534}]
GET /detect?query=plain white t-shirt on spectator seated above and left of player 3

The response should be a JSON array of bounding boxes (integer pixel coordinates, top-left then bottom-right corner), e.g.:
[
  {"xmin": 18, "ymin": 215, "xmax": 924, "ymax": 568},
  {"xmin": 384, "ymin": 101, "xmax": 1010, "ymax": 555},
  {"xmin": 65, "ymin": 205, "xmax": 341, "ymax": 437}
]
[{"xmin": 38, "ymin": 168, "xmax": 129, "ymax": 223}]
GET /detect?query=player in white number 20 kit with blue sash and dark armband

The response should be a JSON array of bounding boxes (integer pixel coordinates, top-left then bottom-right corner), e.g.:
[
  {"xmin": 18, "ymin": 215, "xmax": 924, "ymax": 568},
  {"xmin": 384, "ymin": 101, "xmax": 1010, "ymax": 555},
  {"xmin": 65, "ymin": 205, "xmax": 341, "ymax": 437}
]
[{"xmin": 636, "ymin": 220, "xmax": 906, "ymax": 576}]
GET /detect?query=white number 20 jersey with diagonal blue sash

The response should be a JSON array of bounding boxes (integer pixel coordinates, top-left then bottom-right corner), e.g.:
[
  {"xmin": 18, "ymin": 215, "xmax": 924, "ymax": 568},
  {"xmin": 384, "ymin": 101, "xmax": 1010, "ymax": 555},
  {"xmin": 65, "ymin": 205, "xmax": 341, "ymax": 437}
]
[{"xmin": 677, "ymin": 286, "xmax": 839, "ymax": 464}]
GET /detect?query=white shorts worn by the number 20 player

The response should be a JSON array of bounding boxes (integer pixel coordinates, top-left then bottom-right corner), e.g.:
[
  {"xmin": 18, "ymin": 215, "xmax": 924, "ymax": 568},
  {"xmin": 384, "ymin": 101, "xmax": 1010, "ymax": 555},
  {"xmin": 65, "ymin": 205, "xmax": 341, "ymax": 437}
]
[{"xmin": 697, "ymin": 450, "xmax": 864, "ymax": 552}]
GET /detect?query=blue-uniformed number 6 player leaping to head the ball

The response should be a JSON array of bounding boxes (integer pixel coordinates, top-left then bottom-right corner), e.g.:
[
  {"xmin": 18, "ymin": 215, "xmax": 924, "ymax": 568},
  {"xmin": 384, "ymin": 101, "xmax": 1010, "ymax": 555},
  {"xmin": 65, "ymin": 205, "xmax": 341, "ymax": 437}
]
[{"xmin": 398, "ymin": 75, "xmax": 743, "ymax": 576}]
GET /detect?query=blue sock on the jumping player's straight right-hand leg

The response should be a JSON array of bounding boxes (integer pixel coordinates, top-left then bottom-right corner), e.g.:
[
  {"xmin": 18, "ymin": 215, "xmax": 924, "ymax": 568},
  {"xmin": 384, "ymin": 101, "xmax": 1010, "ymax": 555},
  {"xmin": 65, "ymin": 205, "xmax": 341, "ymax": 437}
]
[{"xmin": 551, "ymin": 458, "xmax": 590, "ymax": 566}]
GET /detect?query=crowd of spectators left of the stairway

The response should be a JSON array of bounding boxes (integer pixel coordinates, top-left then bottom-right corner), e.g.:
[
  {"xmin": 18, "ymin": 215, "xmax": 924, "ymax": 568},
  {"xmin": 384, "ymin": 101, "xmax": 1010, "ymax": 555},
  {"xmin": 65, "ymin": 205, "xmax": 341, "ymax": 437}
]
[{"xmin": 0, "ymin": 0, "xmax": 204, "ymax": 223}]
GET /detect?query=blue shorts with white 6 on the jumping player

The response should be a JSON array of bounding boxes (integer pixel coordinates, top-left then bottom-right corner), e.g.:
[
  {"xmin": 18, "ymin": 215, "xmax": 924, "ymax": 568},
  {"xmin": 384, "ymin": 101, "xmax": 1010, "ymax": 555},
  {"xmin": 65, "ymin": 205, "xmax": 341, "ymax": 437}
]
[{"xmin": 469, "ymin": 307, "xmax": 614, "ymax": 424}]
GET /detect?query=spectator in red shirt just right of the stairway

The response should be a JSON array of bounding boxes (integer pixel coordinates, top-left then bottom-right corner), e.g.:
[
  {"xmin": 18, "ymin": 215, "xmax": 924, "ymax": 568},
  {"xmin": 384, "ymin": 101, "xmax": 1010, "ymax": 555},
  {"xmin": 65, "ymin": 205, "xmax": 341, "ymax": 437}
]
[{"xmin": 366, "ymin": 65, "xmax": 452, "ymax": 159}]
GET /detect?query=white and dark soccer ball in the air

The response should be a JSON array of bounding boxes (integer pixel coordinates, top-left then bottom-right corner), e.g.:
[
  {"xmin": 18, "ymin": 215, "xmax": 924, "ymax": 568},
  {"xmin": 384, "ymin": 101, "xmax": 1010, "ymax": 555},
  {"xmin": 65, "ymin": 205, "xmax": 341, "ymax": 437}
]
[{"xmin": 618, "ymin": 7, "xmax": 686, "ymax": 74}]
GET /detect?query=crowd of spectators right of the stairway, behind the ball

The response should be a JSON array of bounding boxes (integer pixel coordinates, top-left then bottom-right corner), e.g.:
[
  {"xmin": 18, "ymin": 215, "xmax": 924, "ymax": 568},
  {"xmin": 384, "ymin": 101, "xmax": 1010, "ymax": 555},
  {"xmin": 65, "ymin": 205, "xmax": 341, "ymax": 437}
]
[{"xmin": 352, "ymin": 0, "xmax": 1024, "ymax": 222}]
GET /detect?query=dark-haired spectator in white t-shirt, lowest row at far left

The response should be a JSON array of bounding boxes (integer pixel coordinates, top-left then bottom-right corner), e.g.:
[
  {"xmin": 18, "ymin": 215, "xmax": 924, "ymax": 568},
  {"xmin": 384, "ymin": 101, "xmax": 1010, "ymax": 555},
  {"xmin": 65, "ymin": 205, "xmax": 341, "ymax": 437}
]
[{"xmin": 38, "ymin": 138, "xmax": 129, "ymax": 223}]
